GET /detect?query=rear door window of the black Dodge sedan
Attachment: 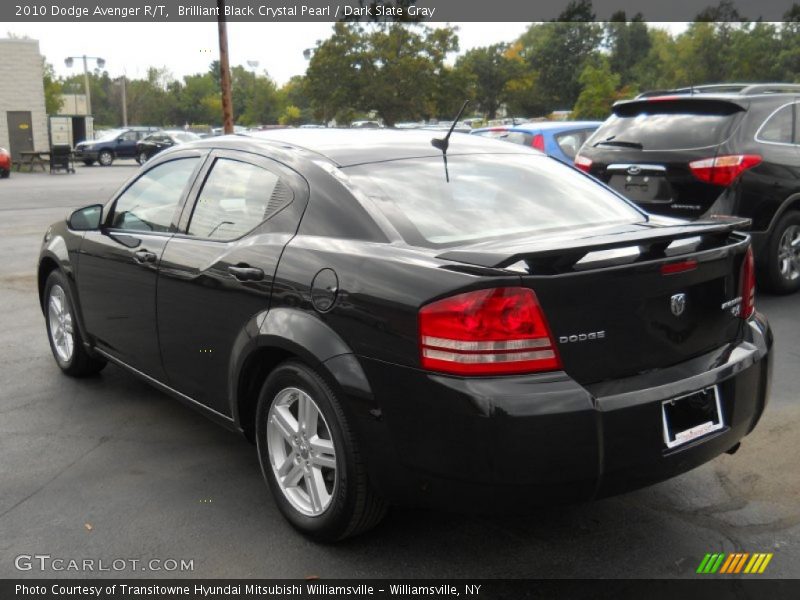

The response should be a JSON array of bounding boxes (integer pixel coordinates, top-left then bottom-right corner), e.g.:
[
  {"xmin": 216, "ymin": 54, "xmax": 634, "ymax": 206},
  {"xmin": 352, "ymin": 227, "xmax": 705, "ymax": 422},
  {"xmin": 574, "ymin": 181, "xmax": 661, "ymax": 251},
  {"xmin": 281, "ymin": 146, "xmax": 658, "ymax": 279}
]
[{"xmin": 187, "ymin": 158, "xmax": 292, "ymax": 240}]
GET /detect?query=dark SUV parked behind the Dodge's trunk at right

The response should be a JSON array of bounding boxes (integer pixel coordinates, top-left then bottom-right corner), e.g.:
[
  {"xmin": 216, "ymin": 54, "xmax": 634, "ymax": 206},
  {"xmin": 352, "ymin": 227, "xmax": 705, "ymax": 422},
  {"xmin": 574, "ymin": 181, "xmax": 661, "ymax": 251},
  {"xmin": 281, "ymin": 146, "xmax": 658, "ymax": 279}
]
[{"xmin": 575, "ymin": 84, "xmax": 800, "ymax": 293}]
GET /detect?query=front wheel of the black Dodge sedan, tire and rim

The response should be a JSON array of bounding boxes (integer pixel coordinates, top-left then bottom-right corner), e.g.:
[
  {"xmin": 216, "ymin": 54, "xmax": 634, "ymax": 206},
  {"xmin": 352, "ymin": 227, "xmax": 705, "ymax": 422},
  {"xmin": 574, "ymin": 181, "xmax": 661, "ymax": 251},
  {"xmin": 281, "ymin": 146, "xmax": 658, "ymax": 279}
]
[{"xmin": 44, "ymin": 270, "xmax": 106, "ymax": 377}]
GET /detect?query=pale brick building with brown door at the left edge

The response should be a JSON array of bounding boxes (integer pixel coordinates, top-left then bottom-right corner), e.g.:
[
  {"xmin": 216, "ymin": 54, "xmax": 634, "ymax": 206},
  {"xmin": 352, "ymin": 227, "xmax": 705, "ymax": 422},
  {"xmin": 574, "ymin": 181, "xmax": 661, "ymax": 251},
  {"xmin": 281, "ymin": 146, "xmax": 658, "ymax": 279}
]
[{"xmin": 0, "ymin": 39, "xmax": 49, "ymax": 161}]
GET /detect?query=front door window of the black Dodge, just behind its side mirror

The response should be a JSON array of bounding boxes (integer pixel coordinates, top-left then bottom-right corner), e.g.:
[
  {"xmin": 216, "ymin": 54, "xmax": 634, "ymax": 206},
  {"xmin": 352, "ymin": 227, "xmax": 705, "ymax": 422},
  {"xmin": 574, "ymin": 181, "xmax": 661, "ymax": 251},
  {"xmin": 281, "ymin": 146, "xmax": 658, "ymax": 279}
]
[{"xmin": 111, "ymin": 158, "xmax": 200, "ymax": 232}]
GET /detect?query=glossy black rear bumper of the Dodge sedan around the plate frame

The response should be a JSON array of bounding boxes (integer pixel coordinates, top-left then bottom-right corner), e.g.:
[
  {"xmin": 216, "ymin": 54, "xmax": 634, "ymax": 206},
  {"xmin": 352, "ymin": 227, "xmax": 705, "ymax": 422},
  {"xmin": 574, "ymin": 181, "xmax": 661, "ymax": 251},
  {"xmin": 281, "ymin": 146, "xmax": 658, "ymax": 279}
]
[{"xmin": 352, "ymin": 315, "xmax": 772, "ymax": 512}]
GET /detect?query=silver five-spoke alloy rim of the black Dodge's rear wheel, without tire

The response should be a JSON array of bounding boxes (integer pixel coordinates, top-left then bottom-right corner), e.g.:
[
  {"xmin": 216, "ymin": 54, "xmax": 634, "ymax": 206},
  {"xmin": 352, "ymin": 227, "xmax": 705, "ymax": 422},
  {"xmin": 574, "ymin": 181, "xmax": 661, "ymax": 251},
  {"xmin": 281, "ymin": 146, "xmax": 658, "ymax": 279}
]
[{"xmin": 267, "ymin": 387, "xmax": 338, "ymax": 517}]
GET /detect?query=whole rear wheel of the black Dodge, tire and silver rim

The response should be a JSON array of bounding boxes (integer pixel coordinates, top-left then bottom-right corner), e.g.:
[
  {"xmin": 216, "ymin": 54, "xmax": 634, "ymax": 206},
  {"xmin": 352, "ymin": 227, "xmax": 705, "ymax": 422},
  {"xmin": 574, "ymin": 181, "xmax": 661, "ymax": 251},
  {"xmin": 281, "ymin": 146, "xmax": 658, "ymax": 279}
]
[{"xmin": 256, "ymin": 361, "xmax": 386, "ymax": 542}]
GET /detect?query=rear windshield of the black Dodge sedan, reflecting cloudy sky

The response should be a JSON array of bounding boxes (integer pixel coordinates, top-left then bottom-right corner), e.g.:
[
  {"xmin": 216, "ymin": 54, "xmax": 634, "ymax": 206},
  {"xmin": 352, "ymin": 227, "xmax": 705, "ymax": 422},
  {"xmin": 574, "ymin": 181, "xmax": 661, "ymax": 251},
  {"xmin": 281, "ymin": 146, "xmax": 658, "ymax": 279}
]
[{"xmin": 344, "ymin": 152, "xmax": 645, "ymax": 247}]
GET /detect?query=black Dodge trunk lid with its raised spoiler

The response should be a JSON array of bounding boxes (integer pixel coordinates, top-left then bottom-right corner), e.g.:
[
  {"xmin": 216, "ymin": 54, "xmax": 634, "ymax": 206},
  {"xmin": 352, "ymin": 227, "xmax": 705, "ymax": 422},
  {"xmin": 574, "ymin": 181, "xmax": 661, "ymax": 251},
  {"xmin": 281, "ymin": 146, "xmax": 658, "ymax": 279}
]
[{"xmin": 440, "ymin": 220, "xmax": 749, "ymax": 384}]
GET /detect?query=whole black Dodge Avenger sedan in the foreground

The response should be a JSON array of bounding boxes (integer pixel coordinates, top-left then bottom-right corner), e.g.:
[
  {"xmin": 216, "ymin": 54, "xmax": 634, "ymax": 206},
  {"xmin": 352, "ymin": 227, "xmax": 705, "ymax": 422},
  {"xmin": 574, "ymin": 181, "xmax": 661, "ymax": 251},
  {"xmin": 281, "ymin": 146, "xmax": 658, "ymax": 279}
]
[{"xmin": 38, "ymin": 130, "xmax": 772, "ymax": 540}]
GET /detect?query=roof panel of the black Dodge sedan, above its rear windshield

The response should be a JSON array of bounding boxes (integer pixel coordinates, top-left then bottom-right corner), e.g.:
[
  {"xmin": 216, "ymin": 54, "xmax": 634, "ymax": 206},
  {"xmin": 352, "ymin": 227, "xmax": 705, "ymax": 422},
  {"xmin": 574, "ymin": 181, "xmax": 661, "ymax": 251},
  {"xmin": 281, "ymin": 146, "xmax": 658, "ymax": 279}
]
[{"xmin": 242, "ymin": 129, "xmax": 531, "ymax": 167}]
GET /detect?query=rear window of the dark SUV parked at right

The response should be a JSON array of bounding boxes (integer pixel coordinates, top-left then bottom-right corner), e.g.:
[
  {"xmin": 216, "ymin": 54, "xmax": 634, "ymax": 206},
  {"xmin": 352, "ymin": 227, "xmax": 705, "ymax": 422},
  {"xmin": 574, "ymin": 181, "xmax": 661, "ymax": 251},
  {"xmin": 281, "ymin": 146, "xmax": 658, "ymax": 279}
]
[{"xmin": 587, "ymin": 100, "xmax": 742, "ymax": 151}]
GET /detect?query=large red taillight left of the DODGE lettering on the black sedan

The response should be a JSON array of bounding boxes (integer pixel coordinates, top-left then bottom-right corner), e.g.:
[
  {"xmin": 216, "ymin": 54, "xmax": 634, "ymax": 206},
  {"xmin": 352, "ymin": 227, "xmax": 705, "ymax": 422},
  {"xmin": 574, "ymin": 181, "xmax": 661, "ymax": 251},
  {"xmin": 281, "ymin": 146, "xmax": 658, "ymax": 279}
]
[{"xmin": 419, "ymin": 287, "xmax": 561, "ymax": 375}]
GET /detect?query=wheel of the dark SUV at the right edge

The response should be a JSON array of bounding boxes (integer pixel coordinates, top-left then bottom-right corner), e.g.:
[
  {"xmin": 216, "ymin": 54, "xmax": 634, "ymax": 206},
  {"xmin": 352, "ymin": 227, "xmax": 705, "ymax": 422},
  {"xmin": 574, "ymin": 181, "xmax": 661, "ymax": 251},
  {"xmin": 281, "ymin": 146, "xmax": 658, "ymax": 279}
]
[{"xmin": 765, "ymin": 211, "xmax": 800, "ymax": 294}]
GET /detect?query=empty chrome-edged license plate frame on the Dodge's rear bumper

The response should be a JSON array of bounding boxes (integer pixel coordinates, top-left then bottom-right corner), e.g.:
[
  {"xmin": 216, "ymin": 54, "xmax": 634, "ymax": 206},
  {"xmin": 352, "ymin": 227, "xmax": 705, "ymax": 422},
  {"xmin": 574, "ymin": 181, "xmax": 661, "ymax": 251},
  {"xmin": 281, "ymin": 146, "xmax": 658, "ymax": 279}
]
[{"xmin": 661, "ymin": 385, "xmax": 725, "ymax": 450}]
